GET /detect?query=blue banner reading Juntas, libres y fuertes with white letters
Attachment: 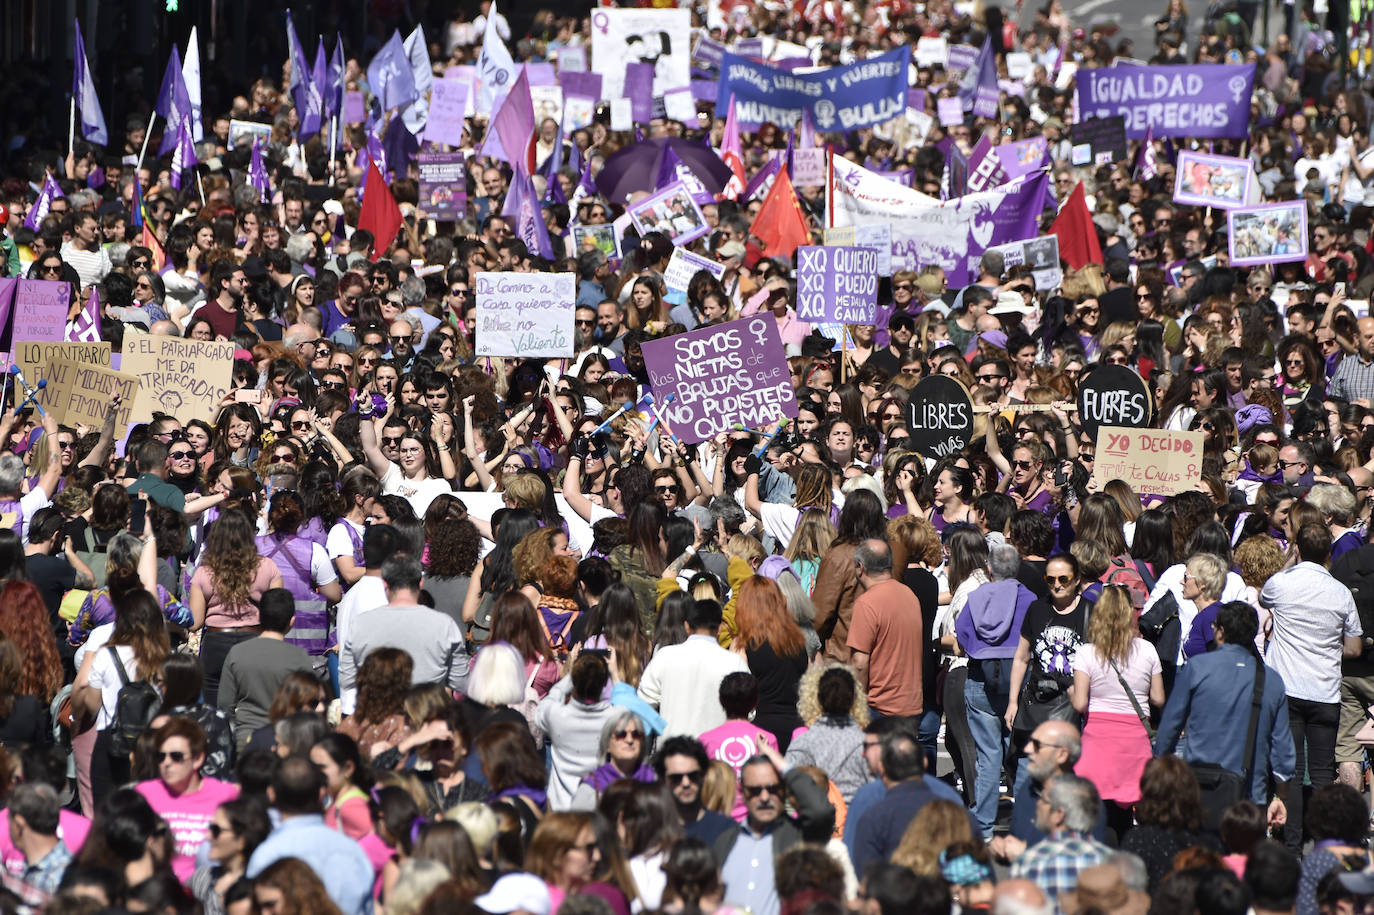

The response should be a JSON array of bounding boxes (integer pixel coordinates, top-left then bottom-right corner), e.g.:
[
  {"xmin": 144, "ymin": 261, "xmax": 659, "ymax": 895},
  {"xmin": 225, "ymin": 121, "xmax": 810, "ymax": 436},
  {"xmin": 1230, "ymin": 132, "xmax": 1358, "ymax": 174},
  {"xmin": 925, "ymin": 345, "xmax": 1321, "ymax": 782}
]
[{"xmin": 716, "ymin": 47, "xmax": 911, "ymax": 131}]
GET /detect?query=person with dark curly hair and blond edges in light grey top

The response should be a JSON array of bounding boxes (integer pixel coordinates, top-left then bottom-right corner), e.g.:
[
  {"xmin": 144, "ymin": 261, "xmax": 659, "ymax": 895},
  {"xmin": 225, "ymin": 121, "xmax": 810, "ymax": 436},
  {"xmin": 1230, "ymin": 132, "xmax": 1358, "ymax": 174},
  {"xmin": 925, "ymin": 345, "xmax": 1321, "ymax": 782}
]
[{"xmin": 786, "ymin": 661, "xmax": 870, "ymax": 804}]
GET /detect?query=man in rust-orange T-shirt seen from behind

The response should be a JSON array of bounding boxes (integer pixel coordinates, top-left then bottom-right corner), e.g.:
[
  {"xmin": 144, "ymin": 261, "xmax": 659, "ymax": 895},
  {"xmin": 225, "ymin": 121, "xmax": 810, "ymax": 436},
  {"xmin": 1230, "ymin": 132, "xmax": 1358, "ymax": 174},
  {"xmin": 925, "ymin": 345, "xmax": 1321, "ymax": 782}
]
[{"xmin": 846, "ymin": 540, "xmax": 925, "ymax": 721}]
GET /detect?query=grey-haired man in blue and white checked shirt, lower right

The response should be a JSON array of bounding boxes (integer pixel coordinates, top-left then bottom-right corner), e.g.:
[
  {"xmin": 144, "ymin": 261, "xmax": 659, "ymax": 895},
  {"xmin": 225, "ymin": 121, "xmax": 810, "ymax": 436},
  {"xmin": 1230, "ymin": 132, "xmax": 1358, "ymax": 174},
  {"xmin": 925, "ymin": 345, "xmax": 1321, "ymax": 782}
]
[{"xmin": 1011, "ymin": 775, "xmax": 1112, "ymax": 899}]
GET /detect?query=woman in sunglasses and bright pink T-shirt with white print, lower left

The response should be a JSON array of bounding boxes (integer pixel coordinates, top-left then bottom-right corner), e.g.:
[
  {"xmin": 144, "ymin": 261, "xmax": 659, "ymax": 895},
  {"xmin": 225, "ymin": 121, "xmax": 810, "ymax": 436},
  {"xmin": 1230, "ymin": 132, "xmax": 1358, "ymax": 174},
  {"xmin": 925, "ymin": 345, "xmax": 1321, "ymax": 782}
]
[{"xmin": 136, "ymin": 716, "xmax": 239, "ymax": 883}]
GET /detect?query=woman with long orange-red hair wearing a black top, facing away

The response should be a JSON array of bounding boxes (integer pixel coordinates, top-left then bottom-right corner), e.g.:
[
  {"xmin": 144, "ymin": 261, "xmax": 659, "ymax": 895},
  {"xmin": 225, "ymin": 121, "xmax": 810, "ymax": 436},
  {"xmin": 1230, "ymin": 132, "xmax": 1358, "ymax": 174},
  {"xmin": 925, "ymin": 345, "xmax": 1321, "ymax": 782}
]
[{"xmin": 731, "ymin": 576, "xmax": 807, "ymax": 753}]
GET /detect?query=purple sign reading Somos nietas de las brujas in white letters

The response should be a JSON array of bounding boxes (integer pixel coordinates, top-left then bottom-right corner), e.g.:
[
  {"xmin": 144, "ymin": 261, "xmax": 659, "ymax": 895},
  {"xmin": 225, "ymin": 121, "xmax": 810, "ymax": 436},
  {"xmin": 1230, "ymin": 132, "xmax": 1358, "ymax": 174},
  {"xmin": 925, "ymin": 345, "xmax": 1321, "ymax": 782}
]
[{"xmin": 643, "ymin": 315, "xmax": 797, "ymax": 445}]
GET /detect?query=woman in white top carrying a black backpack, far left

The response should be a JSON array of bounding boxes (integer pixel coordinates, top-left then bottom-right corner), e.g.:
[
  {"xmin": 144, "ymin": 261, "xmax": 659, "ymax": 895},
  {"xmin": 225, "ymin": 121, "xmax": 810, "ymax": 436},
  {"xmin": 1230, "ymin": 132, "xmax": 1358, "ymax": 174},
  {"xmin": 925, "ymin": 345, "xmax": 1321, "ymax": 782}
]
[{"xmin": 71, "ymin": 567, "xmax": 170, "ymax": 804}]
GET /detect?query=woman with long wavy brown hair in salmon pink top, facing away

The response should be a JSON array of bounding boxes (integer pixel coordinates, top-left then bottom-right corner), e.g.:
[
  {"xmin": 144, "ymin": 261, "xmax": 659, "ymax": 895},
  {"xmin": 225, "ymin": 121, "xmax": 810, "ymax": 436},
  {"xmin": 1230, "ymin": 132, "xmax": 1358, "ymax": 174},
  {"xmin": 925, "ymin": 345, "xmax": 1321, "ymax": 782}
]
[{"xmin": 187, "ymin": 503, "xmax": 282, "ymax": 706}]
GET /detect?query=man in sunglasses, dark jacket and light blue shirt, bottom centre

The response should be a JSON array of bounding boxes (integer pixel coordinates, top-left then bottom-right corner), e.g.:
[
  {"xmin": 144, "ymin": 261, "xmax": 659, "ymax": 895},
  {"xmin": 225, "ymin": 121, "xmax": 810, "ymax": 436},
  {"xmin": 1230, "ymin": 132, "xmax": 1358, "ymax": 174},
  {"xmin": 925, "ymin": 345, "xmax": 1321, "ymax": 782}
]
[{"xmin": 713, "ymin": 741, "xmax": 835, "ymax": 915}]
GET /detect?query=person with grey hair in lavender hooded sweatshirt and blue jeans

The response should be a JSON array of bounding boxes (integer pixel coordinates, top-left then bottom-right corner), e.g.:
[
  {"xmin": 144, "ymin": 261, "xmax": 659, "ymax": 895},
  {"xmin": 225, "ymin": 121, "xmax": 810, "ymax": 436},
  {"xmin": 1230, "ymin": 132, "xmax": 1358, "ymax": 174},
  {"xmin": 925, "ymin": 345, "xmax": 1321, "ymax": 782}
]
[{"xmin": 945, "ymin": 544, "xmax": 1035, "ymax": 841}]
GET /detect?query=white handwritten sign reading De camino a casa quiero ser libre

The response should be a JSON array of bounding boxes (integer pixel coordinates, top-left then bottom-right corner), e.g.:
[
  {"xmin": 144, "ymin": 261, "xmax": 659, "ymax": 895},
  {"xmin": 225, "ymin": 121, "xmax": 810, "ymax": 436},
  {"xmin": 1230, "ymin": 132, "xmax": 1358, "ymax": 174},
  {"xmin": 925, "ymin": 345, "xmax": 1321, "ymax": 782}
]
[{"xmin": 473, "ymin": 273, "xmax": 577, "ymax": 359}]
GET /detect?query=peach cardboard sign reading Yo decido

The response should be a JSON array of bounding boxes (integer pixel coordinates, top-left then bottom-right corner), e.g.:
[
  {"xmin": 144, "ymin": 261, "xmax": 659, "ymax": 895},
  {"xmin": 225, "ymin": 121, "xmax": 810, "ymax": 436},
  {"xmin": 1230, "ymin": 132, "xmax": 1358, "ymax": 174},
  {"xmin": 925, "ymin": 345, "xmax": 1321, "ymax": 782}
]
[{"xmin": 1092, "ymin": 426, "xmax": 1204, "ymax": 496}]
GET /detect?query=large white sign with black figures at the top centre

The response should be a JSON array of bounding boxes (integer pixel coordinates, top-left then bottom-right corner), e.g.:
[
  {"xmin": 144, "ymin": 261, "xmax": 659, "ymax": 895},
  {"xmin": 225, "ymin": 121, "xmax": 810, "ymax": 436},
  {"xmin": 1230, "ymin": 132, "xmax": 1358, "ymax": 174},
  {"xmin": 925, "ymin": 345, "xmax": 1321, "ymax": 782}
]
[{"xmin": 591, "ymin": 8, "xmax": 691, "ymax": 99}]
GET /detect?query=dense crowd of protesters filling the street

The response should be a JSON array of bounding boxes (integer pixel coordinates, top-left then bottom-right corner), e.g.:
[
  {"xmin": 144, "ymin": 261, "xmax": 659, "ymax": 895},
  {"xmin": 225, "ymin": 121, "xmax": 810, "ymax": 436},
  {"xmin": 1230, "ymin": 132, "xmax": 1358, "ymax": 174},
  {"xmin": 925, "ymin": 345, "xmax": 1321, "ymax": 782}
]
[{"xmin": 0, "ymin": 0, "xmax": 1374, "ymax": 915}]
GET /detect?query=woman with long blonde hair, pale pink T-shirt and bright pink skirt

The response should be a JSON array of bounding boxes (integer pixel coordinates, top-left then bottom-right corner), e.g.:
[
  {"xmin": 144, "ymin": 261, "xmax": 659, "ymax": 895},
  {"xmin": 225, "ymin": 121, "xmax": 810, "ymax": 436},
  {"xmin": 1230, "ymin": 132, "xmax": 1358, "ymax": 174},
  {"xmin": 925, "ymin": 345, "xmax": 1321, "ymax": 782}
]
[{"xmin": 1069, "ymin": 585, "xmax": 1164, "ymax": 835}]
